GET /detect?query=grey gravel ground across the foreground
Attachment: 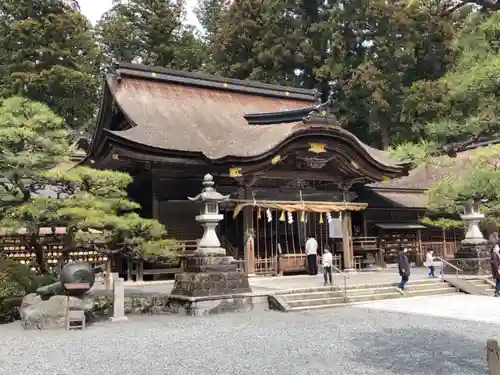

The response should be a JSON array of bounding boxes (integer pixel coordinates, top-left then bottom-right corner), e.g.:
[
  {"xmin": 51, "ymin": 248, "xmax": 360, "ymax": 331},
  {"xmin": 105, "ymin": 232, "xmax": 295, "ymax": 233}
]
[{"xmin": 0, "ymin": 308, "xmax": 499, "ymax": 375}]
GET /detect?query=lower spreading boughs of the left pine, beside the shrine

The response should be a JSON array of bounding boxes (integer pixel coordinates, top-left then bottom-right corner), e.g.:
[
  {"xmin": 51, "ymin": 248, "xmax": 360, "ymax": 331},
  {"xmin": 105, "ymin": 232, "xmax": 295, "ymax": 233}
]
[{"xmin": 5, "ymin": 167, "xmax": 180, "ymax": 262}]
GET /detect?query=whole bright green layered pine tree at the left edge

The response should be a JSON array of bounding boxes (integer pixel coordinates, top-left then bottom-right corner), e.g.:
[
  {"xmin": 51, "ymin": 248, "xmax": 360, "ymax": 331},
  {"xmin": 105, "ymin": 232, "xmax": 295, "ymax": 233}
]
[{"xmin": 0, "ymin": 97, "xmax": 179, "ymax": 270}]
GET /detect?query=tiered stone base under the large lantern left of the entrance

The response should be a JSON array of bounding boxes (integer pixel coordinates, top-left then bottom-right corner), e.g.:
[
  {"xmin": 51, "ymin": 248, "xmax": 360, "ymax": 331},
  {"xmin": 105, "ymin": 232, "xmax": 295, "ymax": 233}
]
[{"xmin": 171, "ymin": 253, "xmax": 252, "ymax": 298}]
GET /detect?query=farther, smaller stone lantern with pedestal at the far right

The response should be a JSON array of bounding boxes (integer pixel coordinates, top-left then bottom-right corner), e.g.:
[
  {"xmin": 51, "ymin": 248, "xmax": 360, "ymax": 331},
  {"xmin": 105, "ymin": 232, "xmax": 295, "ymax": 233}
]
[{"xmin": 455, "ymin": 201, "xmax": 491, "ymax": 275}]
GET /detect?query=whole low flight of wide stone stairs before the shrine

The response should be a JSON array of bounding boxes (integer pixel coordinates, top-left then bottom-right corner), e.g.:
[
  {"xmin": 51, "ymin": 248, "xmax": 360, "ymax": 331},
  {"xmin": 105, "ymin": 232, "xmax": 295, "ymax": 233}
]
[{"xmin": 269, "ymin": 279, "xmax": 458, "ymax": 311}]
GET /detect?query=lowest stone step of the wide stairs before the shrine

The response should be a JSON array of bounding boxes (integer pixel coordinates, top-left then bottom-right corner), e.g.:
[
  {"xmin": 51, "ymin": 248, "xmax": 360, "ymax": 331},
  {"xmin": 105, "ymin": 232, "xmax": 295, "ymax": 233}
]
[{"xmin": 288, "ymin": 287, "xmax": 457, "ymax": 311}]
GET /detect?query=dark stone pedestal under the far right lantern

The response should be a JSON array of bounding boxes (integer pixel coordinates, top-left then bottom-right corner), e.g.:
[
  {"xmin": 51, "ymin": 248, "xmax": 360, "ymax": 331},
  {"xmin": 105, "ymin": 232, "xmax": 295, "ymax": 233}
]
[{"xmin": 452, "ymin": 241, "xmax": 491, "ymax": 275}]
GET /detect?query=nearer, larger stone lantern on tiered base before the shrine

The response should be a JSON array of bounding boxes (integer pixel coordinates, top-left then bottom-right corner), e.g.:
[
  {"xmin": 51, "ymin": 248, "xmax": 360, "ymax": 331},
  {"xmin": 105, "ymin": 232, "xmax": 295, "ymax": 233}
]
[{"xmin": 171, "ymin": 174, "xmax": 252, "ymax": 298}]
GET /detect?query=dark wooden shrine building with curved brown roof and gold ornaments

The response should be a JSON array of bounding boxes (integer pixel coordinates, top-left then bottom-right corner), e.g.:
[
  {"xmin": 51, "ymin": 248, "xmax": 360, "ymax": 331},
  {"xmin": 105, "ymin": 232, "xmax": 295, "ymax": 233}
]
[{"xmin": 82, "ymin": 63, "xmax": 460, "ymax": 280}]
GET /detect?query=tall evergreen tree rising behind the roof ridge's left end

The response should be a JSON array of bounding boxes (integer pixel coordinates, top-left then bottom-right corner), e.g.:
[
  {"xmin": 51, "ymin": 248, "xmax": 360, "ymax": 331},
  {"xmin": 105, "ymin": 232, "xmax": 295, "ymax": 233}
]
[{"xmin": 96, "ymin": 0, "xmax": 204, "ymax": 70}]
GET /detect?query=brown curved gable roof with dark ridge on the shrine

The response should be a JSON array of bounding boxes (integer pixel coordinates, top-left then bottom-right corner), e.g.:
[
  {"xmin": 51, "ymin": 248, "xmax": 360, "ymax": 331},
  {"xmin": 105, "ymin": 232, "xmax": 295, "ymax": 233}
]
[{"xmin": 91, "ymin": 64, "xmax": 406, "ymax": 179}]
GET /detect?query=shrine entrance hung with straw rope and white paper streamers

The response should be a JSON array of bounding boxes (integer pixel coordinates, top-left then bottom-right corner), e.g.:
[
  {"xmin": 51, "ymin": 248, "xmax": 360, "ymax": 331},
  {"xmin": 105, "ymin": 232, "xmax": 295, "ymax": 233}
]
[{"xmin": 233, "ymin": 200, "xmax": 366, "ymax": 275}]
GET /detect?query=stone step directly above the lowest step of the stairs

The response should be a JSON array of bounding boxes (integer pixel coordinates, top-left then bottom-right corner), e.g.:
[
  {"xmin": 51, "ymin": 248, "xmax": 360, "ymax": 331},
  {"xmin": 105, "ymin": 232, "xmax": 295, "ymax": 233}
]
[{"xmin": 282, "ymin": 283, "xmax": 447, "ymax": 301}]
